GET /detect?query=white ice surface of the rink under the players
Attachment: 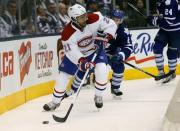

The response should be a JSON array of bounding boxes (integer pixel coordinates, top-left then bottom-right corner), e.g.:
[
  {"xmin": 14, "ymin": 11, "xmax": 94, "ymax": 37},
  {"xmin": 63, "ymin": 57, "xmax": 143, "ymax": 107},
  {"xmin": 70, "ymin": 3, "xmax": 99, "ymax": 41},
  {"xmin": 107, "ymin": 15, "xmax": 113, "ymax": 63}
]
[{"xmin": 0, "ymin": 77, "xmax": 180, "ymax": 131}]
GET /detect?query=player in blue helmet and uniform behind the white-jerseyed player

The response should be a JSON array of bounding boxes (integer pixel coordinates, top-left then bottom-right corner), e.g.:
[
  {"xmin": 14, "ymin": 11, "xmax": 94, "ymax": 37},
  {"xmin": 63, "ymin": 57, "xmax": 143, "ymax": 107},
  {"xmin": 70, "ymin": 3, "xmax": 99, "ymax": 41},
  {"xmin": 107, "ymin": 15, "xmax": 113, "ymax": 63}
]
[{"xmin": 106, "ymin": 10, "xmax": 132, "ymax": 96}]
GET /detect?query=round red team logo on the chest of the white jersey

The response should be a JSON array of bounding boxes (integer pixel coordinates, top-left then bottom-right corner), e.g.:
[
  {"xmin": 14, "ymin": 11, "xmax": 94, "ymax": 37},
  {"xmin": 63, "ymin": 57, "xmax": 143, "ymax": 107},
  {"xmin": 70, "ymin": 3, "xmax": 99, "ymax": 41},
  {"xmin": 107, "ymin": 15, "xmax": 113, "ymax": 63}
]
[{"xmin": 77, "ymin": 35, "xmax": 92, "ymax": 48}]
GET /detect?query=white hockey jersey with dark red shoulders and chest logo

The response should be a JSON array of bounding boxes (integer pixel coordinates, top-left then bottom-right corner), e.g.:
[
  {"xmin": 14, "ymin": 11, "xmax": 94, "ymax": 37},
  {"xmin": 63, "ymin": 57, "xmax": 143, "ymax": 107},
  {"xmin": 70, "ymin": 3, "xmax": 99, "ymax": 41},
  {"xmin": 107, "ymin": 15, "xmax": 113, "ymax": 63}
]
[{"xmin": 61, "ymin": 12, "xmax": 117, "ymax": 64}]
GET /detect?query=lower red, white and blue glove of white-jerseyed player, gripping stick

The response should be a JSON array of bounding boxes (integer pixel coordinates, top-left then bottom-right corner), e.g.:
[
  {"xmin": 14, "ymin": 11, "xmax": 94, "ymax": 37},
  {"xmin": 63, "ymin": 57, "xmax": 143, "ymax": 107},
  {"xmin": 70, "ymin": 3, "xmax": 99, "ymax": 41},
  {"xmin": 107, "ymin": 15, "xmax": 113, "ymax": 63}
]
[{"xmin": 78, "ymin": 57, "xmax": 95, "ymax": 71}]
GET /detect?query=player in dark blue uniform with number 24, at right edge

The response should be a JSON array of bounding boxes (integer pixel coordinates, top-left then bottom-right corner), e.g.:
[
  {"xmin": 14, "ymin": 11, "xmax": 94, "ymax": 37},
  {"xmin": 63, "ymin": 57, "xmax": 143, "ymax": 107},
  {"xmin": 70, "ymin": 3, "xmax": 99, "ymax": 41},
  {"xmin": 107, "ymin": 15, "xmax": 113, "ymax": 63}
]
[{"xmin": 147, "ymin": 0, "xmax": 180, "ymax": 83}]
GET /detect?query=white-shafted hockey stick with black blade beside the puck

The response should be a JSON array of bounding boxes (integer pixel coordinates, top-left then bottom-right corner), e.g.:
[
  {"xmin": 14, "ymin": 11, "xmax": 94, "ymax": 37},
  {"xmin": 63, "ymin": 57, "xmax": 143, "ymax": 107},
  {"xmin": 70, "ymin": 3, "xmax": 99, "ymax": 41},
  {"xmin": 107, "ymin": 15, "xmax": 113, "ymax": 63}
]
[{"xmin": 52, "ymin": 50, "xmax": 98, "ymax": 123}]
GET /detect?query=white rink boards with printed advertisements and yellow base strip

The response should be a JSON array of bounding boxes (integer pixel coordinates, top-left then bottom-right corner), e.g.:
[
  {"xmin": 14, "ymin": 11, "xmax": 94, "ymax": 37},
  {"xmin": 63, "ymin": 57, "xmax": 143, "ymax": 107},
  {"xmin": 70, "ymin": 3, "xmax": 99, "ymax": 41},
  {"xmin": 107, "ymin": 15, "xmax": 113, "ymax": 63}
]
[{"xmin": 0, "ymin": 29, "xmax": 180, "ymax": 114}]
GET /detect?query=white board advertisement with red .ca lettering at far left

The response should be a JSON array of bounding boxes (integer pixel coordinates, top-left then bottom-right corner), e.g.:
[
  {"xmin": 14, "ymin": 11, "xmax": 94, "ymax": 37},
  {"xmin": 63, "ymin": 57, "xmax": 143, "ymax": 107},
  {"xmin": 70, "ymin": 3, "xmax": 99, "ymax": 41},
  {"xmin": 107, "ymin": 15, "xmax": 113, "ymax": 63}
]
[{"xmin": 0, "ymin": 42, "xmax": 19, "ymax": 97}]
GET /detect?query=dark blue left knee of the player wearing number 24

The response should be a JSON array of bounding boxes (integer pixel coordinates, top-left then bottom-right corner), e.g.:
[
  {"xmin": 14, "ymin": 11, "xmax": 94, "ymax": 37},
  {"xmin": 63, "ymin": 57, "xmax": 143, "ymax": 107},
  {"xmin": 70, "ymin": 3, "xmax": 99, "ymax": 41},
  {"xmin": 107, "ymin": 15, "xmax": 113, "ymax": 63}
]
[{"xmin": 153, "ymin": 41, "xmax": 166, "ymax": 54}]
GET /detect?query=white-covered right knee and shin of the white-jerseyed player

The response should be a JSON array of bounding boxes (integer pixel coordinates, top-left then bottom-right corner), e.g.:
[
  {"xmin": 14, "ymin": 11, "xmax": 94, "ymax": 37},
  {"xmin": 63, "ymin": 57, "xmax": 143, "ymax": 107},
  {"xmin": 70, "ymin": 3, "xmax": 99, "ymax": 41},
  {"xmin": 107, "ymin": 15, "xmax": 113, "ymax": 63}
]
[{"xmin": 95, "ymin": 63, "xmax": 108, "ymax": 89}]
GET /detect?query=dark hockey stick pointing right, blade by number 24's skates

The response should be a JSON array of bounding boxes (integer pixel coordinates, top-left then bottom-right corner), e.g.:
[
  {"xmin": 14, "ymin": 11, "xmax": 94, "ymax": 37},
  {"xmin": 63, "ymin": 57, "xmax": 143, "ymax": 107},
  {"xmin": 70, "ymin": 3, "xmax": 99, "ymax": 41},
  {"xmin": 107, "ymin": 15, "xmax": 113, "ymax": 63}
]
[{"xmin": 123, "ymin": 61, "xmax": 167, "ymax": 81}]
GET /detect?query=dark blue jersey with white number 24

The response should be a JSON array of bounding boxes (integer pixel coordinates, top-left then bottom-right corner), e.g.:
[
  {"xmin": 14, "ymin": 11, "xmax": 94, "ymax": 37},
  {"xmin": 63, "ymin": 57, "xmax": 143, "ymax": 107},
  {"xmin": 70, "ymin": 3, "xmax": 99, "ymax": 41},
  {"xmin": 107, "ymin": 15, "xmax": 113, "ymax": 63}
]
[{"xmin": 157, "ymin": 0, "xmax": 180, "ymax": 31}]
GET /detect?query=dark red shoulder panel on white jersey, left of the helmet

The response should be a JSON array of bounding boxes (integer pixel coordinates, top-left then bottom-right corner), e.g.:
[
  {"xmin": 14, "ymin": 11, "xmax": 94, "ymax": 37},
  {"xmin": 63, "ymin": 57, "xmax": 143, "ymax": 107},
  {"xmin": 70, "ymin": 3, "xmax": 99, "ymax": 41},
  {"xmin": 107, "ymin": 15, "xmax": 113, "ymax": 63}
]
[{"xmin": 61, "ymin": 22, "xmax": 76, "ymax": 41}]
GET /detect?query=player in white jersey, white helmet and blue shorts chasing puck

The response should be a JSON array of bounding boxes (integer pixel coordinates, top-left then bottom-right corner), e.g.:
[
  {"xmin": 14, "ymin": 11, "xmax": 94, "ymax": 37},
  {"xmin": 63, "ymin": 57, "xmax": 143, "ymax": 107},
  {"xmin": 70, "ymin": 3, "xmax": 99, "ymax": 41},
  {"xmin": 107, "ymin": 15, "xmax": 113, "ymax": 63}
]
[{"xmin": 43, "ymin": 4, "xmax": 117, "ymax": 111}]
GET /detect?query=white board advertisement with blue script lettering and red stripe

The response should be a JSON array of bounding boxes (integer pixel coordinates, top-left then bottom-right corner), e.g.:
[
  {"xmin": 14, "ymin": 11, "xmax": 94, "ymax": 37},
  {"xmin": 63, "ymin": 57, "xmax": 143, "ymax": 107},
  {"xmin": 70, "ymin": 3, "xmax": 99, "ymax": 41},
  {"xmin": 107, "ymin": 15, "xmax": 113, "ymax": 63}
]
[{"xmin": 128, "ymin": 29, "xmax": 158, "ymax": 67}]
